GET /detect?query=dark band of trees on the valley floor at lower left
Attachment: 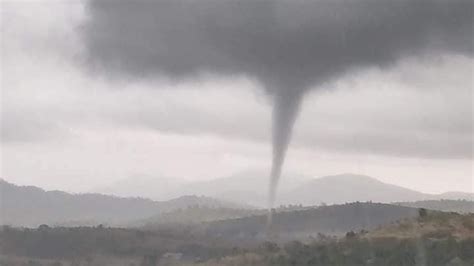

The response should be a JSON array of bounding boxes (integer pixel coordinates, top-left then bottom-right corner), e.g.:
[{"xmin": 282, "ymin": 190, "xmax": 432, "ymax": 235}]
[{"xmin": 0, "ymin": 226, "xmax": 233, "ymax": 260}]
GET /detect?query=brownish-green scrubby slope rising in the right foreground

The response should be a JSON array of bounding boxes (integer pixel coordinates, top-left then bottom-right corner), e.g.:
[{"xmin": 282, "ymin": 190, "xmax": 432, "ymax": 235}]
[{"xmin": 186, "ymin": 209, "xmax": 474, "ymax": 266}]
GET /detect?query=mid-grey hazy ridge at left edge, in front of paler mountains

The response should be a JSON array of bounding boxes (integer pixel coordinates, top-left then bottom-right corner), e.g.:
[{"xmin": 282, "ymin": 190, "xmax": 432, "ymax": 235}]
[{"xmin": 0, "ymin": 179, "xmax": 248, "ymax": 227}]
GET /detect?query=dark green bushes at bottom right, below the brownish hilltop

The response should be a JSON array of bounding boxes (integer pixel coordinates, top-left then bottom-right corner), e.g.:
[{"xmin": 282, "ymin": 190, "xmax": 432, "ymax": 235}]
[{"xmin": 266, "ymin": 238, "xmax": 474, "ymax": 266}]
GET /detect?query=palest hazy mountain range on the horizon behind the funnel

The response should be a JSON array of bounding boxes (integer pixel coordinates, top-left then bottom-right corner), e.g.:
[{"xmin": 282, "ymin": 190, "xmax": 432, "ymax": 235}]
[{"xmin": 96, "ymin": 171, "xmax": 474, "ymax": 207}]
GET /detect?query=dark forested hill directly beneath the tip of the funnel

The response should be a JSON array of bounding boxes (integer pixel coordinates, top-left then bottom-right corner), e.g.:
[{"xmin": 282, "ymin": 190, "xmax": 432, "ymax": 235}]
[{"xmin": 207, "ymin": 202, "xmax": 418, "ymax": 239}]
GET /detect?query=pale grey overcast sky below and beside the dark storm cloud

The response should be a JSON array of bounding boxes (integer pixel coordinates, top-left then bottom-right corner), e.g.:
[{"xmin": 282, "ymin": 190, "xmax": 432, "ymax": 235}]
[{"xmin": 1, "ymin": 1, "xmax": 474, "ymax": 192}]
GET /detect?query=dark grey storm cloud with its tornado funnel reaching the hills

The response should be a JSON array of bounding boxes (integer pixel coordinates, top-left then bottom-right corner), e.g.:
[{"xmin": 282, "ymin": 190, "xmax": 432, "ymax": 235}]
[{"xmin": 81, "ymin": 0, "xmax": 473, "ymax": 208}]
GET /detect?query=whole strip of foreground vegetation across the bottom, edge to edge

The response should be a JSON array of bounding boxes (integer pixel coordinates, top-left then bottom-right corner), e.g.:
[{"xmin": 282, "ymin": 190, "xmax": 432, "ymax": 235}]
[{"xmin": 0, "ymin": 209, "xmax": 474, "ymax": 266}]
